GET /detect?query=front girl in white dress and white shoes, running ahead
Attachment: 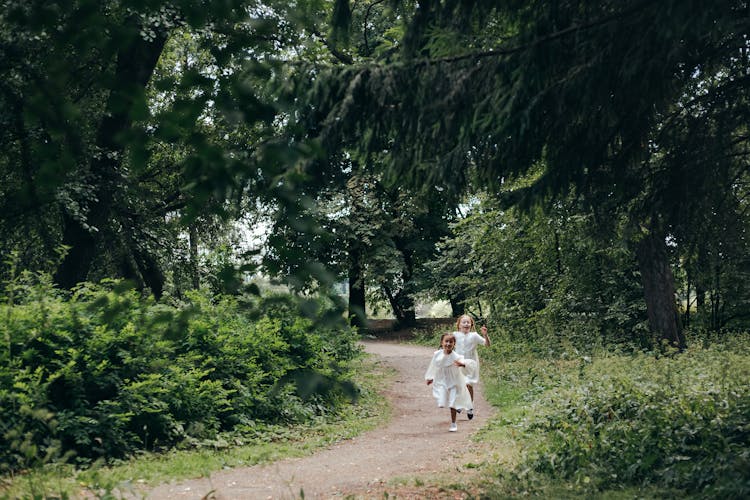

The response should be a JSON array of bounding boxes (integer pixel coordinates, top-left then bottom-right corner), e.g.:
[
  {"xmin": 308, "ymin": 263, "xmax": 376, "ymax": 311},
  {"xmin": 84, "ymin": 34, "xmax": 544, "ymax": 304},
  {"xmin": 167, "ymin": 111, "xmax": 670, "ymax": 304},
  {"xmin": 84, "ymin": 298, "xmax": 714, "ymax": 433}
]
[{"xmin": 424, "ymin": 333, "xmax": 473, "ymax": 432}]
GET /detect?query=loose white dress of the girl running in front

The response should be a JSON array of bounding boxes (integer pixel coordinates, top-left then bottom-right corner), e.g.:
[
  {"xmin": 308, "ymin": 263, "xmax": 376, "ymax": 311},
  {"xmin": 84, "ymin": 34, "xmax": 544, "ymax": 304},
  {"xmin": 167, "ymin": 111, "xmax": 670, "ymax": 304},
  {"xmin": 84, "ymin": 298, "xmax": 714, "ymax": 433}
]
[{"xmin": 424, "ymin": 349, "xmax": 473, "ymax": 410}]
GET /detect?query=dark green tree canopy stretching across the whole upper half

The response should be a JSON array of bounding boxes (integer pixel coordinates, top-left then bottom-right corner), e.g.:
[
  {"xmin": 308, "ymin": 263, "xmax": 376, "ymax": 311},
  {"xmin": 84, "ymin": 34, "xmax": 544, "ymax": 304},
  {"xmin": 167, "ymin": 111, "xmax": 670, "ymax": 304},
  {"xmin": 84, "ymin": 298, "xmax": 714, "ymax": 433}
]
[{"xmin": 0, "ymin": 0, "xmax": 748, "ymax": 345}]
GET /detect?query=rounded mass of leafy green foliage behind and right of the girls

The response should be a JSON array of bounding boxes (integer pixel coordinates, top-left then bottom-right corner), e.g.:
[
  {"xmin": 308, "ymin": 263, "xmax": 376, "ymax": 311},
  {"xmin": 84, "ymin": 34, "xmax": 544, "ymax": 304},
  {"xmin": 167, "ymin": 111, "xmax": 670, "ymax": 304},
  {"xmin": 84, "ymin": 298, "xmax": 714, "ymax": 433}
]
[{"xmin": 430, "ymin": 194, "xmax": 652, "ymax": 350}]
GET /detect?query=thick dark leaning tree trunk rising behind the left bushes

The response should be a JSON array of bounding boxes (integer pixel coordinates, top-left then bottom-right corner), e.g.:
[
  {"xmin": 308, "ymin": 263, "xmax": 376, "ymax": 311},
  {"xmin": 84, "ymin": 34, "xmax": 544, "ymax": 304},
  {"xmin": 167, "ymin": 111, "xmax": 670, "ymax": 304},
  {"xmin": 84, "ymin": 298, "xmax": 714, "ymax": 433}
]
[{"xmin": 55, "ymin": 24, "xmax": 166, "ymax": 295}]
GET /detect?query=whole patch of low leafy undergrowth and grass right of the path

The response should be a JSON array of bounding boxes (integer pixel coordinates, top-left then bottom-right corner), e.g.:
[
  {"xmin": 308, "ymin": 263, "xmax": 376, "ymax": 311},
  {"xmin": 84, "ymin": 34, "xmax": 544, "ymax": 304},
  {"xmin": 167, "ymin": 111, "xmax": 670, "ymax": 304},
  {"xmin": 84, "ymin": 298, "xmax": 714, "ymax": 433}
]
[{"xmin": 483, "ymin": 334, "xmax": 750, "ymax": 498}]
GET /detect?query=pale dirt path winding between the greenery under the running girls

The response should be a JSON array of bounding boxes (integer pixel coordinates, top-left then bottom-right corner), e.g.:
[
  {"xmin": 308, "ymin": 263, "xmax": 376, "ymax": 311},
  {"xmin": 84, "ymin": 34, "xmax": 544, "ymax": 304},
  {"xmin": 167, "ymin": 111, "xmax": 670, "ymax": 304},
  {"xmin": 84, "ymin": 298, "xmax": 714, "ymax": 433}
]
[{"xmin": 147, "ymin": 342, "xmax": 491, "ymax": 500}]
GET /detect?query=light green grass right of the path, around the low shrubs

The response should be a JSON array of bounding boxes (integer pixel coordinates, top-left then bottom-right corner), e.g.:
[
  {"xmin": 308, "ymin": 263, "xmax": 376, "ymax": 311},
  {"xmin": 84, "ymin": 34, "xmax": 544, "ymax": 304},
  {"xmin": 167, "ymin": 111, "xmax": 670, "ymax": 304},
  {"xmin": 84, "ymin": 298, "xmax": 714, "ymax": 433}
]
[{"xmin": 387, "ymin": 332, "xmax": 750, "ymax": 500}]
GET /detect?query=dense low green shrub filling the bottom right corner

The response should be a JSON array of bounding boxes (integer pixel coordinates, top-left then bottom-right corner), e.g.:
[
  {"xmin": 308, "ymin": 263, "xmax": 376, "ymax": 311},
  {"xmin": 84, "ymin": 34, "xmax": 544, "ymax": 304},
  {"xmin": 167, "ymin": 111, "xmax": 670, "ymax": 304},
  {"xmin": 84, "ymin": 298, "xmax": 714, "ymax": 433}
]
[{"xmin": 529, "ymin": 348, "xmax": 750, "ymax": 498}]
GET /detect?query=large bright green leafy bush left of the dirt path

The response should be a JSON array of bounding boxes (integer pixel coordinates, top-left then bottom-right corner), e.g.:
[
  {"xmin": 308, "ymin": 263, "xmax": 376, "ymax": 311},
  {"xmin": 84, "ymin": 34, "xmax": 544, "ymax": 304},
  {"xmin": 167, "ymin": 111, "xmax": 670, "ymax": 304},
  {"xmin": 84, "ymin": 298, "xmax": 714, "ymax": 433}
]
[{"xmin": 0, "ymin": 274, "xmax": 357, "ymax": 472}]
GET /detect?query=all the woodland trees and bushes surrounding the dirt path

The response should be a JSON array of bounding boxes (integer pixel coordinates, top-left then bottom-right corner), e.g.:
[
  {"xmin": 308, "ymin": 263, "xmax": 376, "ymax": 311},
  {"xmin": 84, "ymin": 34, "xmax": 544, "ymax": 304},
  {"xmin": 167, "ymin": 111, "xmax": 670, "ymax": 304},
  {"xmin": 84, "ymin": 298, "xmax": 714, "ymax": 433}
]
[{"xmin": 0, "ymin": 0, "xmax": 750, "ymax": 496}]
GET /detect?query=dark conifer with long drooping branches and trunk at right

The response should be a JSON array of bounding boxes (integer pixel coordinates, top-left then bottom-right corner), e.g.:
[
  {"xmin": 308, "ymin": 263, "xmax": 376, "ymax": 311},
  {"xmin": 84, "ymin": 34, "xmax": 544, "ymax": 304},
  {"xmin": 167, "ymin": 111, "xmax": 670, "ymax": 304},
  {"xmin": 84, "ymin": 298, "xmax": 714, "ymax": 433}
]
[{"xmin": 296, "ymin": 0, "xmax": 749, "ymax": 346}]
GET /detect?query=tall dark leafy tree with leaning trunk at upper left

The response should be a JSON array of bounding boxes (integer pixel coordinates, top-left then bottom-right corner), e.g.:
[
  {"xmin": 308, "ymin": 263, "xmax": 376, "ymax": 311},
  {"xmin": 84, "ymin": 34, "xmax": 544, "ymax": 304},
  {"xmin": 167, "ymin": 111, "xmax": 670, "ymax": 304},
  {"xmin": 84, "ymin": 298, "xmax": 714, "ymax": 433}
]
[{"xmin": 0, "ymin": 0, "xmax": 280, "ymax": 296}]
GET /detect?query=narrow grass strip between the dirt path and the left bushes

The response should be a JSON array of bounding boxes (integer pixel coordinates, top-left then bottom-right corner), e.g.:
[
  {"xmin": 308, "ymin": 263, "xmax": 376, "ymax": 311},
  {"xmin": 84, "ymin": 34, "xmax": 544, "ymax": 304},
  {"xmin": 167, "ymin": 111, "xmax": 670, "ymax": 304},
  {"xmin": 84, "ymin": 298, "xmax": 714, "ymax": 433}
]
[{"xmin": 0, "ymin": 355, "xmax": 394, "ymax": 499}]
